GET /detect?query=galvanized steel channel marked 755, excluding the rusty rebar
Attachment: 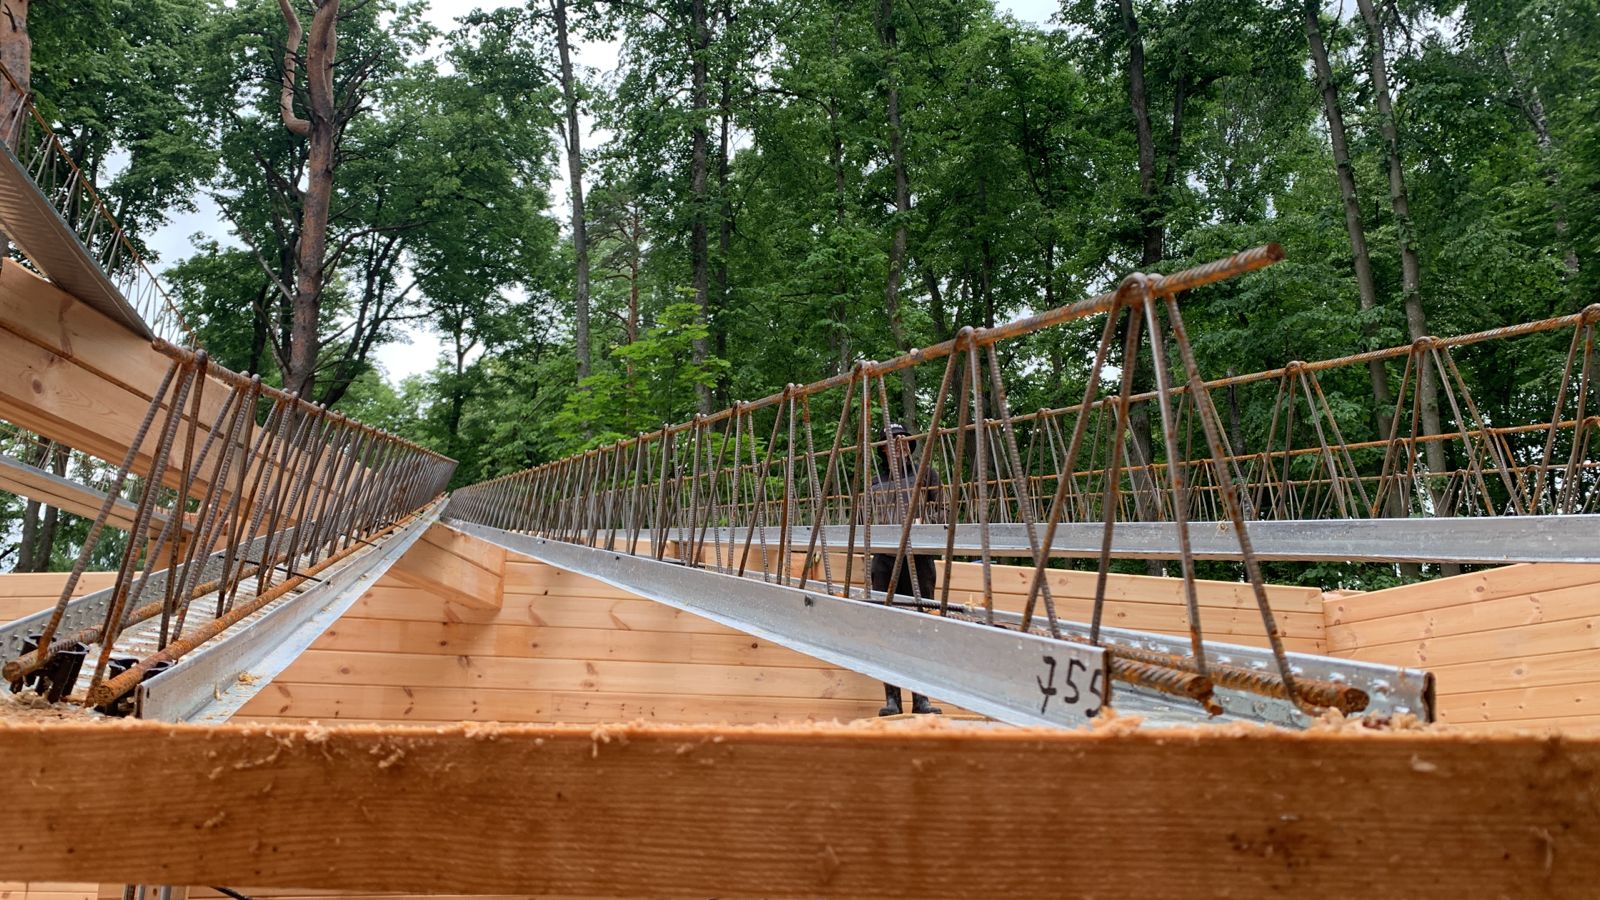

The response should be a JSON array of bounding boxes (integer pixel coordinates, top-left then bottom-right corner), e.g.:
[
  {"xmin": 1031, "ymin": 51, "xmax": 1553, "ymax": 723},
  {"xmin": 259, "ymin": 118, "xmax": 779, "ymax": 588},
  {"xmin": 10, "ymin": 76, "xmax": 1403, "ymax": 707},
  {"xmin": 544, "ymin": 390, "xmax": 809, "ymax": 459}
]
[{"xmin": 450, "ymin": 520, "xmax": 1434, "ymax": 729}]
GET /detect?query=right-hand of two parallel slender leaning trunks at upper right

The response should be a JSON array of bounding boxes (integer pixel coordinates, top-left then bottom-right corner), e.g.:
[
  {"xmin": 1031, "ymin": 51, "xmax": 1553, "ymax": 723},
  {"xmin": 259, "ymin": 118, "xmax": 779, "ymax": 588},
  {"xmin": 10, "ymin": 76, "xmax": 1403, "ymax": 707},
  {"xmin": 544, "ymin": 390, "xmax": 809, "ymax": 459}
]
[{"xmin": 1357, "ymin": 0, "xmax": 1446, "ymax": 514}]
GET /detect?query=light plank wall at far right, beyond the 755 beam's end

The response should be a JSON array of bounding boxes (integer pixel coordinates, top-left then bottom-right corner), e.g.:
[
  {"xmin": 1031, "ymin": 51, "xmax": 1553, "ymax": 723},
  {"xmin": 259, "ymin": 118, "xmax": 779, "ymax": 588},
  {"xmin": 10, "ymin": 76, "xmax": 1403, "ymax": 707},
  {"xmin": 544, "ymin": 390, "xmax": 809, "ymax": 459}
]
[{"xmin": 1325, "ymin": 565, "xmax": 1600, "ymax": 733}]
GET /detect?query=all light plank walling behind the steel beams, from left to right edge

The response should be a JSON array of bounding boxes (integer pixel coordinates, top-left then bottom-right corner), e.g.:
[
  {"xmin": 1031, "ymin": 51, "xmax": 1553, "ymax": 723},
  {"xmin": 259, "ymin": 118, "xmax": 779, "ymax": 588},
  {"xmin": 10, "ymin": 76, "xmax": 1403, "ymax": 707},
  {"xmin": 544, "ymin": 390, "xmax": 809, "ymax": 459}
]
[{"xmin": 0, "ymin": 533, "xmax": 1600, "ymax": 733}]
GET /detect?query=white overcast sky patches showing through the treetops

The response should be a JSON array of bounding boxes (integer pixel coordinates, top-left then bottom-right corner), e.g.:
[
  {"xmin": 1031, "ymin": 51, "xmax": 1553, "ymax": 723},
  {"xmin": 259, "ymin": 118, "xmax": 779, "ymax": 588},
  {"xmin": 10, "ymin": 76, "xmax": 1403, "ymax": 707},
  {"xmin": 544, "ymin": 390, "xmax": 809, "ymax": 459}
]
[{"xmin": 140, "ymin": 0, "xmax": 1061, "ymax": 381}]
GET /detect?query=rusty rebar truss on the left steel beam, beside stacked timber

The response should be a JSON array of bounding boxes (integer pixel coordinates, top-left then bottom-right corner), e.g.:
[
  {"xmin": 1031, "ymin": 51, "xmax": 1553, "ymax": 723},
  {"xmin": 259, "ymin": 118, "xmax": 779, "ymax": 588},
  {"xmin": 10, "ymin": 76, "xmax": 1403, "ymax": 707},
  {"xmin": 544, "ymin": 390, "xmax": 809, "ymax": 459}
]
[{"xmin": 0, "ymin": 340, "xmax": 454, "ymax": 716}]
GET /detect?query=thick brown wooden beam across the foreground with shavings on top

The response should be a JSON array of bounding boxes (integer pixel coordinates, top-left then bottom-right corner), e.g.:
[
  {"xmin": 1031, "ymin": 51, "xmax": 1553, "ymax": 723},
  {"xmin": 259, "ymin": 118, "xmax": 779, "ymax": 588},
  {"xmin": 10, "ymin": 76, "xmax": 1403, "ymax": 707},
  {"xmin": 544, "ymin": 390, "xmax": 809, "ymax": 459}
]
[{"xmin": 0, "ymin": 722, "xmax": 1600, "ymax": 900}]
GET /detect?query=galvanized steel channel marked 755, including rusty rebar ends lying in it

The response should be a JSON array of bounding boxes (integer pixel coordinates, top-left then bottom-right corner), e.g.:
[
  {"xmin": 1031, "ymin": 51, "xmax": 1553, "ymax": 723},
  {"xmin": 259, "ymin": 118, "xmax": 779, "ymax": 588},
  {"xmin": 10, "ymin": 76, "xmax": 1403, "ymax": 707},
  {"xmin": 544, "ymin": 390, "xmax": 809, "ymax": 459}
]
[{"xmin": 450, "ymin": 520, "xmax": 1434, "ymax": 727}]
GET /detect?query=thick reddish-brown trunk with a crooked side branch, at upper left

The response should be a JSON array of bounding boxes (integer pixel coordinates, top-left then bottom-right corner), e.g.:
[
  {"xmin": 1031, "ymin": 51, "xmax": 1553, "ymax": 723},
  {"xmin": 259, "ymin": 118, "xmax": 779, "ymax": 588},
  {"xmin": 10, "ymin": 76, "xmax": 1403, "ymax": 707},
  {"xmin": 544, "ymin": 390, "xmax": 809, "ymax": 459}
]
[{"xmin": 278, "ymin": 0, "xmax": 339, "ymax": 399}]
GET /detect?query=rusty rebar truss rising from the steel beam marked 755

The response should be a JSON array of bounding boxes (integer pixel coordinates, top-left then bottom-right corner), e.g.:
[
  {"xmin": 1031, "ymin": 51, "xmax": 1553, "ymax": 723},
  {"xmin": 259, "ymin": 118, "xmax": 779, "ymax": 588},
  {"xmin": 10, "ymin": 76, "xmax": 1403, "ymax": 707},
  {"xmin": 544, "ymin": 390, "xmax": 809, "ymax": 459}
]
[{"xmin": 446, "ymin": 245, "xmax": 1459, "ymax": 722}]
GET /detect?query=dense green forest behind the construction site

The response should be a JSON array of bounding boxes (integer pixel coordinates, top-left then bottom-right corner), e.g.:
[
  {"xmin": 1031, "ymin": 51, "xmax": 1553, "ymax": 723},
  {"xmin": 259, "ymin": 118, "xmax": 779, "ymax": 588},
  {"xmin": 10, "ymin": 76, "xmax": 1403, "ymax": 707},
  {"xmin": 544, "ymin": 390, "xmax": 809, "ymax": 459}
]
[{"xmin": 0, "ymin": 0, "xmax": 1600, "ymax": 586}]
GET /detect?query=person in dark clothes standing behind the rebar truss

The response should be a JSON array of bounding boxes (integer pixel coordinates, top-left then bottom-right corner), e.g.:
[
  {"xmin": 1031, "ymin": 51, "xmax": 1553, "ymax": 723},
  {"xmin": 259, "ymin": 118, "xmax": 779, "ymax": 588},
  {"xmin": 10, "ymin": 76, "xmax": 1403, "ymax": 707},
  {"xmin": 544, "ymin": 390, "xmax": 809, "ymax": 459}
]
[{"xmin": 869, "ymin": 424, "xmax": 944, "ymax": 716}]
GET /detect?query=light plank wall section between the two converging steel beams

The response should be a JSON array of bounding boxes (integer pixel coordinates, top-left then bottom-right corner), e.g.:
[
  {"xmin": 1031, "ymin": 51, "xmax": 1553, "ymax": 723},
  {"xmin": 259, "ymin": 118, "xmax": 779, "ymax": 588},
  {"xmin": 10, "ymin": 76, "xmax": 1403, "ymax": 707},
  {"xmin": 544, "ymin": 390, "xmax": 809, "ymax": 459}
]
[{"xmin": 238, "ymin": 527, "xmax": 883, "ymax": 724}]
